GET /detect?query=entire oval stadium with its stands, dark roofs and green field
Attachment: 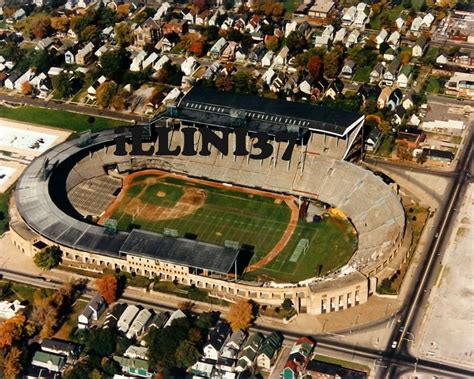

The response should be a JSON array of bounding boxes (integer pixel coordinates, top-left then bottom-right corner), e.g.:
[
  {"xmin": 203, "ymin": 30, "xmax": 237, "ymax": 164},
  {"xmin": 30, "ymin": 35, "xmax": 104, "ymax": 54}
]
[{"xmin": 10, "ymin": 87, "xmax": 405, "ymax": 314}]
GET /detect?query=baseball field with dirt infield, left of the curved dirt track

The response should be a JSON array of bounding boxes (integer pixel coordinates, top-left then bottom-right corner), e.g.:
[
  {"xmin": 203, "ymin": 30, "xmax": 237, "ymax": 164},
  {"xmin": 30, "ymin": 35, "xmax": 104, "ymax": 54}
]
[{"xmin": 112, "ymin": 175, "xmax": 291, "ymax": 264}]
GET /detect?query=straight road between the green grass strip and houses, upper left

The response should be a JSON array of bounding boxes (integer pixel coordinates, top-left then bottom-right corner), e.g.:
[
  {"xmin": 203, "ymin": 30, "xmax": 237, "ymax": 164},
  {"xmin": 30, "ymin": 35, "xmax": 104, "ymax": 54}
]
[{"xmin": 0, "ymin": 93, "xmax": 147, "ymax": 123}]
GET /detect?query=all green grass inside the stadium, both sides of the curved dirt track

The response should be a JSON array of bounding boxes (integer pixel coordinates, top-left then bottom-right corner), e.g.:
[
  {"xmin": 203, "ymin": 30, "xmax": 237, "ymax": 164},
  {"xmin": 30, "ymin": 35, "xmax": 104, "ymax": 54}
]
[{"xmin": 111, "ymin": 174, "xmax": 357, "ymax": 281}]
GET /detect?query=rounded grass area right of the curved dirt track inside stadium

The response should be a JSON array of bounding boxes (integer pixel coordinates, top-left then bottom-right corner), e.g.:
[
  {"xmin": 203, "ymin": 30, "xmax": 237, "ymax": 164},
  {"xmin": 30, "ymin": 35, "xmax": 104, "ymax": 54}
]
[{"xmin": 248, "ymin": 217, "xmax": 357, "ymax": 282}]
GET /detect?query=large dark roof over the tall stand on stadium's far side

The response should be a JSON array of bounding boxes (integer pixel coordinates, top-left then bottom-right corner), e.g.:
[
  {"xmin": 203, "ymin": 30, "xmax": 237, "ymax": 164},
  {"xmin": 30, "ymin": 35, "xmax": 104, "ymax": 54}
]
[{"xmin": 177, "ymin": 87, "xmax": 364, "ymax": 137}]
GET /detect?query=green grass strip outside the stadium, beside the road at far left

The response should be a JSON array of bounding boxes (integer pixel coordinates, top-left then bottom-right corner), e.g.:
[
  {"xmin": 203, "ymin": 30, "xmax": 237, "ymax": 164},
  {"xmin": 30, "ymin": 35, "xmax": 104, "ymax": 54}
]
[{"xmin": 0, "ymin": 106, "xmax": 127, "ymax": 132}]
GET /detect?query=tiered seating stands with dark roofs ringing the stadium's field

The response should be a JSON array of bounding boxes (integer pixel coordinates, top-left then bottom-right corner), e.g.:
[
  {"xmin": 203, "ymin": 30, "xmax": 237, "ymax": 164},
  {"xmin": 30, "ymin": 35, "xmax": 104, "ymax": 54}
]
[{"xmin": 11, "ymin": 88, "xmax": 405, "ymax": 316}]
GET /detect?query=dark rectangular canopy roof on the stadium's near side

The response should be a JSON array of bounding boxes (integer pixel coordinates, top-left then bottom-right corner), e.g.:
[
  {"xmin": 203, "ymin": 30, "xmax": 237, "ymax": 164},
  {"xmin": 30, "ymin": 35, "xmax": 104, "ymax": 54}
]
[{"xmin": 120, "ymin": 229, "xmax": 239, "ymax": 274}]
